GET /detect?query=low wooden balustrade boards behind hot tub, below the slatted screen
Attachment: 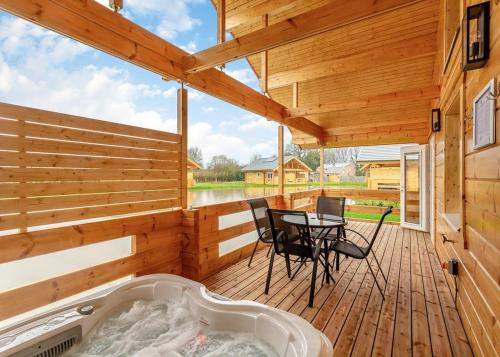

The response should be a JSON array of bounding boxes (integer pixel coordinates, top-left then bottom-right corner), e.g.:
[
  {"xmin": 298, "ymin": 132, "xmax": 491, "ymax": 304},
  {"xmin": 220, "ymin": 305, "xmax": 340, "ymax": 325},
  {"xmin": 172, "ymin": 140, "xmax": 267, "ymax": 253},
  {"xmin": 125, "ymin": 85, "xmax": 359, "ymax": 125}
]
[{"xmin": 0, "ymin": 210, "xmax": 182, "ymax": 320}]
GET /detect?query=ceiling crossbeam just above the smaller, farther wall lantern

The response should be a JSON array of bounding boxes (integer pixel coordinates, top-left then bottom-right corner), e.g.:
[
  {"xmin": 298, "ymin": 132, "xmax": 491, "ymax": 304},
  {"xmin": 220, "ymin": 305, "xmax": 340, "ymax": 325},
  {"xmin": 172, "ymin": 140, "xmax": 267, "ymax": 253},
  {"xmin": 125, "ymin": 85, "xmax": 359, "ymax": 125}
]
[{"xmin": 290, "ymin": 86, "xmax": 440, "ymax": 117}]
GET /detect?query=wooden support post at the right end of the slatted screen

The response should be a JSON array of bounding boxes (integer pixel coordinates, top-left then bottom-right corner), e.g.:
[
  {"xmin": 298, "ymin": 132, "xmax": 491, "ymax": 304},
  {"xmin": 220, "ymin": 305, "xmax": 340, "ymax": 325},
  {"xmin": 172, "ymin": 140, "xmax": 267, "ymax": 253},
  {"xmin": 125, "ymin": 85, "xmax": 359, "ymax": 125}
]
[{"xmin": 177, "ymin": 88, "xmax": 188, "ymax": 208}]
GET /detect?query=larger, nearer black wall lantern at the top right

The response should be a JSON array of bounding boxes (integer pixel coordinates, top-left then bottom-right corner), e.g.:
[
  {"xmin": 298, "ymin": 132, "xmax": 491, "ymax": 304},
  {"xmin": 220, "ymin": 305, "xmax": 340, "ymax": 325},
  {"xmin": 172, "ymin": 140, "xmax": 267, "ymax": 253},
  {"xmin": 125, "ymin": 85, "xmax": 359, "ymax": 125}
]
[{"xmin": 462, "ymin": 1, "xmax": 490, "ymax": 71}]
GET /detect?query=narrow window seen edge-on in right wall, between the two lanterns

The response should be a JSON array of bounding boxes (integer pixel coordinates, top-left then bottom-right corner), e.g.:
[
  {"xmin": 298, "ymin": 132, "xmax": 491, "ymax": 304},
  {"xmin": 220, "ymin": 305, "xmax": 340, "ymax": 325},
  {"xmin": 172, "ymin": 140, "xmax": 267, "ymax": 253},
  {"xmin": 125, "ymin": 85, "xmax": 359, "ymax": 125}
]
[{"xmin": 444, "ymin": 95, "xmax": 463, "ymax": 231}]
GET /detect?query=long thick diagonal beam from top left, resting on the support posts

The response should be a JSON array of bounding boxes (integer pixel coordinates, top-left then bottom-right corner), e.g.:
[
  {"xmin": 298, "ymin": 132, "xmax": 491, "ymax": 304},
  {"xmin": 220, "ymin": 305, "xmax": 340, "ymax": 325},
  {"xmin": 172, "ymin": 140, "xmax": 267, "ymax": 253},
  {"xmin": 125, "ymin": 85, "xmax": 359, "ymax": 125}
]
[{"xmin": 0, "ymin": 0, "xmax": 321, "ymax": 136}]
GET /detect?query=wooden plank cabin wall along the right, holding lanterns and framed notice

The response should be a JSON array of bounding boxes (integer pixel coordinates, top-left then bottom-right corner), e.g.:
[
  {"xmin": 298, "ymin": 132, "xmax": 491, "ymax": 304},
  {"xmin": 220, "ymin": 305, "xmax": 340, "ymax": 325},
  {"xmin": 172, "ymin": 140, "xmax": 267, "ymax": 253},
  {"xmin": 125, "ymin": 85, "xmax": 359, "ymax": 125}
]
[{"xmin": 435, "ymin": 0, "xmax": 500, "ymax": 356}]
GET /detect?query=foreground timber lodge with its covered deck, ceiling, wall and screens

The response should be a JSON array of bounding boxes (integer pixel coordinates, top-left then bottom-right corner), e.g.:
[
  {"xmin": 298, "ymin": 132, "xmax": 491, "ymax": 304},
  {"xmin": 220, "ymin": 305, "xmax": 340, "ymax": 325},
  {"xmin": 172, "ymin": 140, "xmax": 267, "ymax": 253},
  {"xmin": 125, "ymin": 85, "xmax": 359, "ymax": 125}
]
[{"xmin": 0, "ymin": 0, "xmax": 500, "ymax": 356}]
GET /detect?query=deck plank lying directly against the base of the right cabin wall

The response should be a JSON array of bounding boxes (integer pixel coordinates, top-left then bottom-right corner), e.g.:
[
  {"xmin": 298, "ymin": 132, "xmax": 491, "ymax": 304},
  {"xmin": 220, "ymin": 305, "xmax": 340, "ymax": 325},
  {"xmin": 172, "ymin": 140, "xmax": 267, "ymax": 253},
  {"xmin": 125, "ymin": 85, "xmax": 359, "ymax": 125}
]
[{"xmin": 425, "ymin": 232, "xmax": 473, "ymax": 356}]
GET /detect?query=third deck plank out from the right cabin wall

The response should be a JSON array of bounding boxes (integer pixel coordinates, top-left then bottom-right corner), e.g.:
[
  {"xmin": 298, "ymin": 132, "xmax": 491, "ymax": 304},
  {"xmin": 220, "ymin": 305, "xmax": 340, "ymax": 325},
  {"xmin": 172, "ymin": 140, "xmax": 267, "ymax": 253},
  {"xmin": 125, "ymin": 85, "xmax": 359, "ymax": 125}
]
[{"xmin": 410, "ymin": 231, "xmax": 432, "ymax": 356}]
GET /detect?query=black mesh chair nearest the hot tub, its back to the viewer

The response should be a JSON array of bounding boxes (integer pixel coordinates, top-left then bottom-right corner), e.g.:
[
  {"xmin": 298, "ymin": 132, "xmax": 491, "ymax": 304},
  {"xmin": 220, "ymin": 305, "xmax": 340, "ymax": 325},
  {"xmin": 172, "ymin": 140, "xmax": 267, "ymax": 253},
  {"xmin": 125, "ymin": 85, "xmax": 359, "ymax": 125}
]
[{"xmin": 265, "ymin": 209, "xmax": 323, "ymax": 307}]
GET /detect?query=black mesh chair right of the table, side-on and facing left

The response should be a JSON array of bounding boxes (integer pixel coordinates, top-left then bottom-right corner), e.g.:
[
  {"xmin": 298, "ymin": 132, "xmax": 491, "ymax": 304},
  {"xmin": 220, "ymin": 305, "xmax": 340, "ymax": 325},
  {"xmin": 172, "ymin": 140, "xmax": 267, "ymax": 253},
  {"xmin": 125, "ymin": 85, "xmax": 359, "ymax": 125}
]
[{"xmin": 330, "ymin": 207, "xmax": 392, "ymax": 299}]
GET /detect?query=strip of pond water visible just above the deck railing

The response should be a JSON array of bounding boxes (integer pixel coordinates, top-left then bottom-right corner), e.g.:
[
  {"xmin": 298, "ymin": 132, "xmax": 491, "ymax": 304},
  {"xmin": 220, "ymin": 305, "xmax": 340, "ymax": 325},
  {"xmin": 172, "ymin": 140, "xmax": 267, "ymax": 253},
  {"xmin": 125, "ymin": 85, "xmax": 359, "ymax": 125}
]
[{"xmin": 188, "ymin": 186, "xmax": 317, "ymax": 207}]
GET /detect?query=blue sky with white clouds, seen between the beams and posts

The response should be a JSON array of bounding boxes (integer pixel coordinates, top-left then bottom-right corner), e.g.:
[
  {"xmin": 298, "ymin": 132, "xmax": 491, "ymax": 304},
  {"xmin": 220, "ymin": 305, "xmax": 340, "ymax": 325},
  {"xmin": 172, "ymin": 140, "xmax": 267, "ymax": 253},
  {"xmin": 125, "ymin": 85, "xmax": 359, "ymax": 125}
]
[{"xmin": 0, "ymin": 0, "xmax": 291, "ymax": 164}]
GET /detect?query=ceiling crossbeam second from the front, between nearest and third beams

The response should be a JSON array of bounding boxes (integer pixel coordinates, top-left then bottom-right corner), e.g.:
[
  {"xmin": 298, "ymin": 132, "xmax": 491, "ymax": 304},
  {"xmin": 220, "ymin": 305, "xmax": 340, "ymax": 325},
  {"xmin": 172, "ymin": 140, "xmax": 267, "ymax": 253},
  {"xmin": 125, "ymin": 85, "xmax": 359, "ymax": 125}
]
[{"xmin": 269, "ymin": 34, "xmax": 437, "ymax": 89}]
